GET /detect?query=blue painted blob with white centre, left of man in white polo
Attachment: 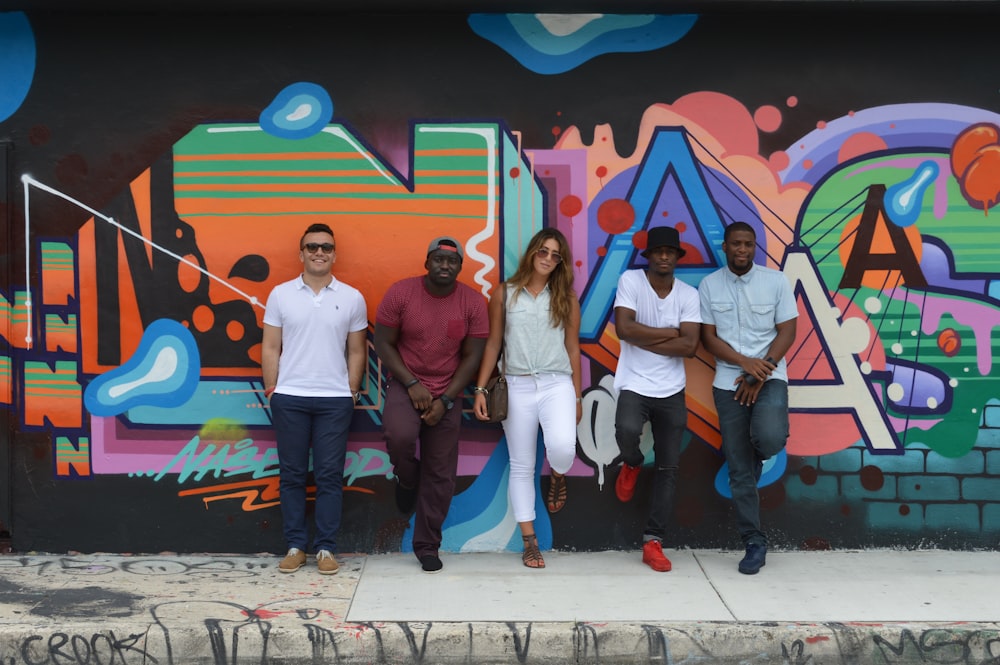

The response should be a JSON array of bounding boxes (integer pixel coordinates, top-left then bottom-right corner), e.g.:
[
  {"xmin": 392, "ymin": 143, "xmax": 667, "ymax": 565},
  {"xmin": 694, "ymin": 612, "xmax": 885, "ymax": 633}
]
[{"xmin": 83, "ymin": 319, "xmax": 201, "ymax": 416}]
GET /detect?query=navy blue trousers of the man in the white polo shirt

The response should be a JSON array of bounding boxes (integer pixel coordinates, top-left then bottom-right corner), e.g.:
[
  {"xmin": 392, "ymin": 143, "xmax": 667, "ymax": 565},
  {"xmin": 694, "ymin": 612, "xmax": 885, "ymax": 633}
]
[{"xmin": 271, "ymin": 393, "xmax": 354, "ymax": 552}]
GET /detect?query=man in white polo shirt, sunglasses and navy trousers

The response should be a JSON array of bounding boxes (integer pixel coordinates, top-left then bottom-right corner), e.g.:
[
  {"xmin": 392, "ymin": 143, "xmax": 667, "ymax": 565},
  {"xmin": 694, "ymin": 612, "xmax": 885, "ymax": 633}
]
[{"xmin": 261, "ymin": 224, "xmax": 368, "ymax": 575}]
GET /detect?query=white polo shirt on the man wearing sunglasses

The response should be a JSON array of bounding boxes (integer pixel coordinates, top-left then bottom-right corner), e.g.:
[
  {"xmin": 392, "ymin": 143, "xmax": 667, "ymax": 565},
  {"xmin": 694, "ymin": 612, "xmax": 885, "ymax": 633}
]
[{"xmin": 264, "ymin": 275, "xmax": 368, "ymax": 397}]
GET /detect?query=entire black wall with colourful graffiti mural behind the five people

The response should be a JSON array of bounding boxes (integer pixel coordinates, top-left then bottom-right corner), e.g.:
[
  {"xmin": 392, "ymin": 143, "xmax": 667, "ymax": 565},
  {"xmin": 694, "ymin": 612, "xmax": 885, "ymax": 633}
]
[{"xmin": 0, "ymin": 3, "xmax": 1000, "ymax": 552}]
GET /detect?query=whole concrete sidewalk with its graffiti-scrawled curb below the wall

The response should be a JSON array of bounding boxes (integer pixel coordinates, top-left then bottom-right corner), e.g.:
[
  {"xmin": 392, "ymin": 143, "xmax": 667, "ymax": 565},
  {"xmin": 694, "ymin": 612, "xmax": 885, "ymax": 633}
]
[{"xmin": 0, "ymin": 550, "xmax": 1000, "ymax": 665}]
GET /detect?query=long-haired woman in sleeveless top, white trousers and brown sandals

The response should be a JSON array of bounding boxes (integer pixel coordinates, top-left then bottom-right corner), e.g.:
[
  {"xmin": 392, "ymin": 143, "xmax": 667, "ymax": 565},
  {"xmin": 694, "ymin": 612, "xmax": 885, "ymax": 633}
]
[{"xmin": 474, "ymin": 228, "xmax": 582, "ymax": 568}]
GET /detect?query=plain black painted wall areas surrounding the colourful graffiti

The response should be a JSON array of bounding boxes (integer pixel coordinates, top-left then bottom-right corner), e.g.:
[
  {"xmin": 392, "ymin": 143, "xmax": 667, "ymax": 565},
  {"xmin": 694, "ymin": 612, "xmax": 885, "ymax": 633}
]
[{"xmin": 0, "ymin": 2, "xmax": 1000, "ymax": 552}]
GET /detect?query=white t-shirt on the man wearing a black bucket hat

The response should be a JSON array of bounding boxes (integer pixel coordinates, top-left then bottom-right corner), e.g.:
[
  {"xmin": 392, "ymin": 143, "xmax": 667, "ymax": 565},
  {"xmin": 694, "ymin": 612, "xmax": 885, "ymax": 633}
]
[{"xmin": 614, "ymin": 269, "xmax": 701, "ymax": 397}]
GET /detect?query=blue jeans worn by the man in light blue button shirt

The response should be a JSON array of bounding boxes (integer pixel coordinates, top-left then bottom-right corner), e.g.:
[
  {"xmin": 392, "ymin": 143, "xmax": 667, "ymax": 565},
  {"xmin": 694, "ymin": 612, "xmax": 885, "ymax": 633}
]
[{"xmin": 712, "ymin": 379, "xmax": 788, "ymax": 546}]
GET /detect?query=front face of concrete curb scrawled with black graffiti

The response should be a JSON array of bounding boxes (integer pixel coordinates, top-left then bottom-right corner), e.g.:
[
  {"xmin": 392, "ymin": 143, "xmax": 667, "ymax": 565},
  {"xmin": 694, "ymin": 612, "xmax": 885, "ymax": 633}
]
[{"xmin": 0, "ymin": 616, "xmax": 1000, "ymax": 665}]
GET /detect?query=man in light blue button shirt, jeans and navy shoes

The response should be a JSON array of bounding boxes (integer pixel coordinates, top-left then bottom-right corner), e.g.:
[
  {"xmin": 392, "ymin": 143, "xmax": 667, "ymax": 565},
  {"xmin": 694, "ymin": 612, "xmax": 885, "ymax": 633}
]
[{"xmin": 698, "ymin": 222, "xmax": 798, "ymax": 575}]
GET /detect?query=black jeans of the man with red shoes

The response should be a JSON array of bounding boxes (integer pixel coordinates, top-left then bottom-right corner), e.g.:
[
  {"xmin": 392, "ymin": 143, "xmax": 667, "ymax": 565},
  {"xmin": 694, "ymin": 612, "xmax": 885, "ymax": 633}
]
[{"xmin": 615, "ymin": 390, "xmax": 687, "ymax": 542}]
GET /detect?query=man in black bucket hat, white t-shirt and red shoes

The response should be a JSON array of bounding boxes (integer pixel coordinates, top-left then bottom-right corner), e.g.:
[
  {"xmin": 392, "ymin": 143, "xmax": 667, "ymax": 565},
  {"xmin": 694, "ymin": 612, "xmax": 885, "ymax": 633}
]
[{"xmin": 615, "ymin": 226, "xmax": 701, "ymax": 572}]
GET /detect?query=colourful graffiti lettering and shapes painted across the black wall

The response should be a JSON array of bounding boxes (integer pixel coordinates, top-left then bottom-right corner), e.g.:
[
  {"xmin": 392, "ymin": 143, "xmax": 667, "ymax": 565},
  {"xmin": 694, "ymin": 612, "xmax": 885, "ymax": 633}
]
[{"xmin": 0, "ymin": 7, "xmax": 1000, "ymax": 551}]
